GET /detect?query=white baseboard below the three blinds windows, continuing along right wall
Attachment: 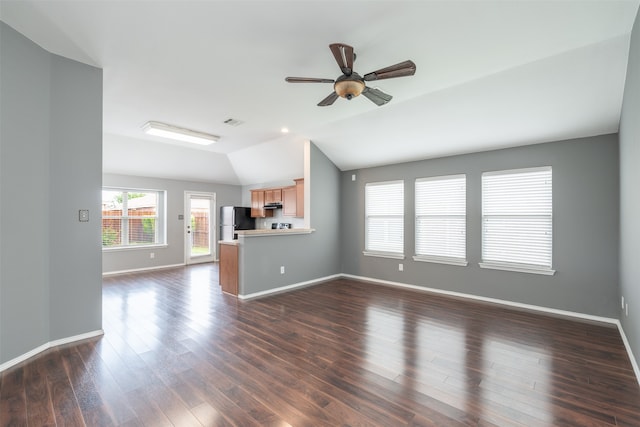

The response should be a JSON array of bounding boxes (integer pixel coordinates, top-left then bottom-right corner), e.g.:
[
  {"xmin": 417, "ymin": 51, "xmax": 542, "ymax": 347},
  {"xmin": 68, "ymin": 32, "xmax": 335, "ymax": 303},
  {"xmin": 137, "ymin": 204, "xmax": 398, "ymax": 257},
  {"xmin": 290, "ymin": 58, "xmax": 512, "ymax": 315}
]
[{"xmin": 341, "ymin": 274, "xmax": 640, "ymax": 384}]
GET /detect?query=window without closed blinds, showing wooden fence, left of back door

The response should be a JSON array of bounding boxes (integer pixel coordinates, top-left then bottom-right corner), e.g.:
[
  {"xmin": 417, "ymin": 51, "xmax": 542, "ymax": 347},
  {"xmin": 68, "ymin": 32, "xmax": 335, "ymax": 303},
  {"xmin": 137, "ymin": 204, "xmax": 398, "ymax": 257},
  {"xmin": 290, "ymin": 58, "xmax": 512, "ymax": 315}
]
[{"xmin": 102, "ymin": 188, "xmax": 165, "ymax": 248}]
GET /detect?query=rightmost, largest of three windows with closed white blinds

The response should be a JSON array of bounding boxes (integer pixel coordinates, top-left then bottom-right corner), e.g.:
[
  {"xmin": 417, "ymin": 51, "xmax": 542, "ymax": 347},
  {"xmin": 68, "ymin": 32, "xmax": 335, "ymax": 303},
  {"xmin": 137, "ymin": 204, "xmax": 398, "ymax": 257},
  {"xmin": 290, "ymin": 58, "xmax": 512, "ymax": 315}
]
[{"xmin": 480, "ymin": 167, "xmax": 554, "ymax": 275}]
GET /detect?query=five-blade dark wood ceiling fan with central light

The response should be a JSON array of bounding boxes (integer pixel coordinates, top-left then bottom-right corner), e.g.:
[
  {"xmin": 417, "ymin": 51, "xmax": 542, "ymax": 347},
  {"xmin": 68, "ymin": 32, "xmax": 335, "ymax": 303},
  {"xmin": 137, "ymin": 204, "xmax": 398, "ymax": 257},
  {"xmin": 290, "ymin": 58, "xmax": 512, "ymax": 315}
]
[{"xmin": 285, "ymin": 43, "xmax": 416, "ymax": 107}]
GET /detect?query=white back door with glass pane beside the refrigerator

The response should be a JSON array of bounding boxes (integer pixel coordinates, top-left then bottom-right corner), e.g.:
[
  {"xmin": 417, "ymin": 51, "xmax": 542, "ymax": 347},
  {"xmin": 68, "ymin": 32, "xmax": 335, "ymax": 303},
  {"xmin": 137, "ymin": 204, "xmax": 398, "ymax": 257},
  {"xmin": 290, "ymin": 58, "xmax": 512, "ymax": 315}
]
[{"xmin": 184, "ymin": 191, "xmax": 217, "ymax": 265}]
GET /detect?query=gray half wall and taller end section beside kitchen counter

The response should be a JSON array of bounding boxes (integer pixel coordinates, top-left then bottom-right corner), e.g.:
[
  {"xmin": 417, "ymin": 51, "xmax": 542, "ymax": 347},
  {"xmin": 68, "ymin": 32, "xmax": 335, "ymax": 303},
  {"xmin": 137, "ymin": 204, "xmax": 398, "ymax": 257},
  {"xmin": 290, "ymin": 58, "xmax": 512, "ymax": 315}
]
[{"xmin": 240, "ymin": 144, "xmax": 340, "ymax": 295}]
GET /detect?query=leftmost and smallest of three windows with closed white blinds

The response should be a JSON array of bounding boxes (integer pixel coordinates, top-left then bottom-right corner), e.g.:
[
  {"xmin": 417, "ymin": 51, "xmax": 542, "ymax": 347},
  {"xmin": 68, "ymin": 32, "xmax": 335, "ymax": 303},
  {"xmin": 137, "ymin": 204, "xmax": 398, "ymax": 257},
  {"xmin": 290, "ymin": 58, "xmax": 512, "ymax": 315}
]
[{"xmin": 364, "ymin": 181, "xmax": 404, "ymax": 258}]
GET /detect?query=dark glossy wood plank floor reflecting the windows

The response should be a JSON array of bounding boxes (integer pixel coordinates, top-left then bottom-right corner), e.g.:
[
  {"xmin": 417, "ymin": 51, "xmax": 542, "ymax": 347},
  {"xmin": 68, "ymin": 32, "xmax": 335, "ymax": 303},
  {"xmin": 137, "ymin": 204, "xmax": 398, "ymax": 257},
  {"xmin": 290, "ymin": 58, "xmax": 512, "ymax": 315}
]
[{"xmin": 0, "ymin": 264, "xmax": 640, "ymax": 426}]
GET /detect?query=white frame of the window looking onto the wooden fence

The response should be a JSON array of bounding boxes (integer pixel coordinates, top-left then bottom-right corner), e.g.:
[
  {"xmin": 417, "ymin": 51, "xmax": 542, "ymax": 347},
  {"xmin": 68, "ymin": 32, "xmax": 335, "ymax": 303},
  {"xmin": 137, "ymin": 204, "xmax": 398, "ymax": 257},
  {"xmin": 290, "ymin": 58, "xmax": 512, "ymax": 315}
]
[{"xmin": 101, "ymin": 186, "xmax": 168, "ymax": 252}]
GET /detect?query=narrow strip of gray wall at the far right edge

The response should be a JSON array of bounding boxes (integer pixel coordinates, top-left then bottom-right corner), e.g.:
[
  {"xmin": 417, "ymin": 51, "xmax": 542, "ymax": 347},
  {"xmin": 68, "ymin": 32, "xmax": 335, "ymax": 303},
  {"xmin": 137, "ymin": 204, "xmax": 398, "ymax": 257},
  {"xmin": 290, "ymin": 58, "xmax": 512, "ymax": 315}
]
[{"xmin": 620, "ymin": 8, "xmax": 640, "ymax": 363}]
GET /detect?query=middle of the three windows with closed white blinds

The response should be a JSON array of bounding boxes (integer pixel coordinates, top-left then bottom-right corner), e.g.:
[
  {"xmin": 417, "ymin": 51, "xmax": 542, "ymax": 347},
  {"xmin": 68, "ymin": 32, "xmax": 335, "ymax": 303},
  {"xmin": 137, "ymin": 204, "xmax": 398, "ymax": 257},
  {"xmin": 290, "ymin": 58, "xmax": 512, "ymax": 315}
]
[{"xmin": 413, "ymin": 175, "xmax": 467, "ymax": 265}]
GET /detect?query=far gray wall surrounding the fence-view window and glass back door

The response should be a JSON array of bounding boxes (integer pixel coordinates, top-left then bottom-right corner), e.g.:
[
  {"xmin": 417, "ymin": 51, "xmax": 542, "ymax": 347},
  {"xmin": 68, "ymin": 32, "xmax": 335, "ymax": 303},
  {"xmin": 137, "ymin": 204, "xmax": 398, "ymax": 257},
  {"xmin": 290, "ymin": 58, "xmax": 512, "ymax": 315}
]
[{"xmin": 102, "ymin": 174, "xmax": 242, "ymax": 273}]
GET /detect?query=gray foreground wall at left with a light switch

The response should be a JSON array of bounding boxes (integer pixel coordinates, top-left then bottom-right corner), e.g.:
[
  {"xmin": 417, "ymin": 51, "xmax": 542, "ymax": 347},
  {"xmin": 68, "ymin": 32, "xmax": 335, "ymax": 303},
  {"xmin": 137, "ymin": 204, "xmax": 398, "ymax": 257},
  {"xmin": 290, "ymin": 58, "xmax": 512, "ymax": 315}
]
[{"xmin": 0, "ymin": 22, "xmax": 102, "ymax": 364}]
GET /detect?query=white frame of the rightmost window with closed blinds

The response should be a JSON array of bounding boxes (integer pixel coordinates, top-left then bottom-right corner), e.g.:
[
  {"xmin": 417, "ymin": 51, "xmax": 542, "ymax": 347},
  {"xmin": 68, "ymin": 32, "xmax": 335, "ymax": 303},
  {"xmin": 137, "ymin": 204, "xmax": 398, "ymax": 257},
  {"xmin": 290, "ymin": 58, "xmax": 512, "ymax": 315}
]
[{"xmin": 478, "ymin": 166, "xmax": 555, "ymax": 275}]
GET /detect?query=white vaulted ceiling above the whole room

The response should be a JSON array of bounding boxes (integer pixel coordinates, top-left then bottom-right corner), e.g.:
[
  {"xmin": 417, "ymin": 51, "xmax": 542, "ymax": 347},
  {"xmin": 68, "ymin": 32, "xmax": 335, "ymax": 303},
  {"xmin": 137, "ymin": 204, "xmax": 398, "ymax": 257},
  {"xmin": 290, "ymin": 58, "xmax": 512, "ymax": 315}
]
[{"xmin": 0, "ymin": 0, "xmax": 640, "ymax": 184}]
